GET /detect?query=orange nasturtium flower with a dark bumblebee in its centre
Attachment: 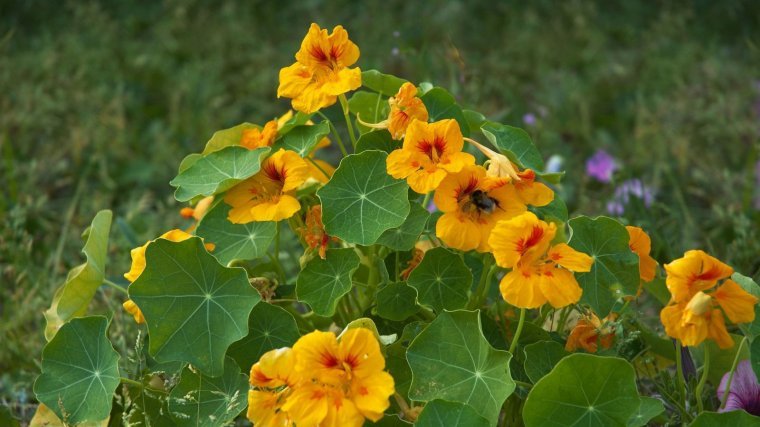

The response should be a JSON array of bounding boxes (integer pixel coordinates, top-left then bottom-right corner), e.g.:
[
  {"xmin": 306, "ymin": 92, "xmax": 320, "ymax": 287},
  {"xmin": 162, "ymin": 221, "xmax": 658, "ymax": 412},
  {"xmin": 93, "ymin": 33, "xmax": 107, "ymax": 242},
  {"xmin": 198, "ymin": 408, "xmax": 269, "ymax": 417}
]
[{"xmin": 433, "ymin": 165, "xmax": 554, "ymax": 252}]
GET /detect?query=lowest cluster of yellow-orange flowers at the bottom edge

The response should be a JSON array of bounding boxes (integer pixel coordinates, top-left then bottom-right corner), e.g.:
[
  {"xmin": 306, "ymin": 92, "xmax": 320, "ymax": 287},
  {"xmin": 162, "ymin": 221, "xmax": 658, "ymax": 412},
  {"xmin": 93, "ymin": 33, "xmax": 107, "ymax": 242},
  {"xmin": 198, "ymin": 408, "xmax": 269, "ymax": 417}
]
[{"xmin": 248, "ymin": 328, "xmax": 394, "ymax": 427}]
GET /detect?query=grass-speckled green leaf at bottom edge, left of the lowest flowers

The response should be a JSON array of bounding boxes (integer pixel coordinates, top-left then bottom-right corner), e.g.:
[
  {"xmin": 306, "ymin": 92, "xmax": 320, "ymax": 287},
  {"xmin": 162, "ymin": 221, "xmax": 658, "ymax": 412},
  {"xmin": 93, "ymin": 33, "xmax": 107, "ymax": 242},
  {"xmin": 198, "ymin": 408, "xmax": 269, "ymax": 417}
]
[{"xmin": 169, "ymin": 357, "xmax": 248, "ymax": 426}]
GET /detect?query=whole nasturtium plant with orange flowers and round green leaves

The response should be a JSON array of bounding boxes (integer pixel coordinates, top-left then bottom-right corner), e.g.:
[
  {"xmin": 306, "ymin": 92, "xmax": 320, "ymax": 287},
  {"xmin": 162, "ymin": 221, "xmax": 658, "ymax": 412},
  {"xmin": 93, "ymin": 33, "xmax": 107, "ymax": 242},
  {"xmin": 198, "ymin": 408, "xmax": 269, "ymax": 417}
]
[{"xmin": 34, "ymin": 20, "xmax": 760, "ymax": 427}]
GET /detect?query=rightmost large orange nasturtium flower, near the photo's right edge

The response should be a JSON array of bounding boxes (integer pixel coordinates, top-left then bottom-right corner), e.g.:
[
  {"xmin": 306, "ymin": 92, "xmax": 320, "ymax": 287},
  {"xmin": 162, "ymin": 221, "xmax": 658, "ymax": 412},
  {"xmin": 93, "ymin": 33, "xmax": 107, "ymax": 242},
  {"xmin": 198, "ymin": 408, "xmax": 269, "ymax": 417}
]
[{"xmin": 660, "ymin": 250, "xmax": 758, "ymax": 348}]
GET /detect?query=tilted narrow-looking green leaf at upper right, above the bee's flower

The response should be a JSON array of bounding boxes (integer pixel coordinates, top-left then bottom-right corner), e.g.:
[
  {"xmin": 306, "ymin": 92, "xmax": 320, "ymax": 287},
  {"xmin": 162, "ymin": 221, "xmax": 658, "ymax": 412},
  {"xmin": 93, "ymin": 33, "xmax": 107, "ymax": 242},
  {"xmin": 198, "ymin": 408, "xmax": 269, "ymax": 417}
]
[{"xmin": 480, "ymin": 122, "xmax": 544, "ymax": 172}]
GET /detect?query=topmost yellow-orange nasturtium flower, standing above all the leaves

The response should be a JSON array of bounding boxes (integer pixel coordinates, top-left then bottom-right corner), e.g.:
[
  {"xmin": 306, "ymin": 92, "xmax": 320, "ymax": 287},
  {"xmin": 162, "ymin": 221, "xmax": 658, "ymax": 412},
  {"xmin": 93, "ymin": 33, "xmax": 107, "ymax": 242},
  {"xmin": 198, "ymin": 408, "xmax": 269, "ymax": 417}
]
[{"xmin": 277, "ymin": 24, "xmax": 362, "ymax": 114}]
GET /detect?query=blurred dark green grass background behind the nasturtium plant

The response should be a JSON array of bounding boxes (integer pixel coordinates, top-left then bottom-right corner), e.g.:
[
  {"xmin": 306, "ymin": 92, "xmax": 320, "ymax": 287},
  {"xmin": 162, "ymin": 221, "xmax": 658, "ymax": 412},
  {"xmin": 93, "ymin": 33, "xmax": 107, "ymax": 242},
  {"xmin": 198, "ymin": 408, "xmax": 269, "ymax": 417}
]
[{"xmin": 0, "ymin": 0, "xmax": 760, "ymax": 422}]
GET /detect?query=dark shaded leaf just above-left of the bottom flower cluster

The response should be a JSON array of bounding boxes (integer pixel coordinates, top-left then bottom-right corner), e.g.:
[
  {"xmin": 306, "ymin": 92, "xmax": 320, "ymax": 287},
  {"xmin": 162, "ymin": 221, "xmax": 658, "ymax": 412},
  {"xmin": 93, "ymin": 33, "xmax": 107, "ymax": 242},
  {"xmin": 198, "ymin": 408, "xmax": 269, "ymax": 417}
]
[{"xmin": 227, "ymin": 302, "xmax": 300, "ymax": 371}]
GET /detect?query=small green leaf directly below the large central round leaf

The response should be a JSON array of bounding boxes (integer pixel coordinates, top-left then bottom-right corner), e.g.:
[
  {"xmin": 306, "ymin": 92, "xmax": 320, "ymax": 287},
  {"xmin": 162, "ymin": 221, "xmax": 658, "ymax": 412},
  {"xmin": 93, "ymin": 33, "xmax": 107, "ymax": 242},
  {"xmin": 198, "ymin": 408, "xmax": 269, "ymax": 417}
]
[{"xmin": 296, "ymin": 248, "xmax": 359, "ymax": 316}]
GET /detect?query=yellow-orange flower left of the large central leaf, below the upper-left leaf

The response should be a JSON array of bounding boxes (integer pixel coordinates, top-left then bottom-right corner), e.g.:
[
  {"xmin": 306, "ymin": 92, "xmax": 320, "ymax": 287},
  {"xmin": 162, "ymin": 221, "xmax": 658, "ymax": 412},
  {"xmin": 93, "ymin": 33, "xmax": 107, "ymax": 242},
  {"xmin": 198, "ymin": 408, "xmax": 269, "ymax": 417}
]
[{"xmin": 224, "ymin": 149, "xmax": 309, "ymax": 224}]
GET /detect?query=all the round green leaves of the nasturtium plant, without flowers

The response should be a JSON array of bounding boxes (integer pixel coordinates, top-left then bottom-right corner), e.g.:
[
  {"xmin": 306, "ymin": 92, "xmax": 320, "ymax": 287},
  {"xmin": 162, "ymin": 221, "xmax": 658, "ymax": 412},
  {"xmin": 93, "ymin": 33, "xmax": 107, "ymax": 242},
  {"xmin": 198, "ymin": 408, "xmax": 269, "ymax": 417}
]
[{"xmin": 26, "ymin": 46, "xmax": 760, "ymax": 426}]
